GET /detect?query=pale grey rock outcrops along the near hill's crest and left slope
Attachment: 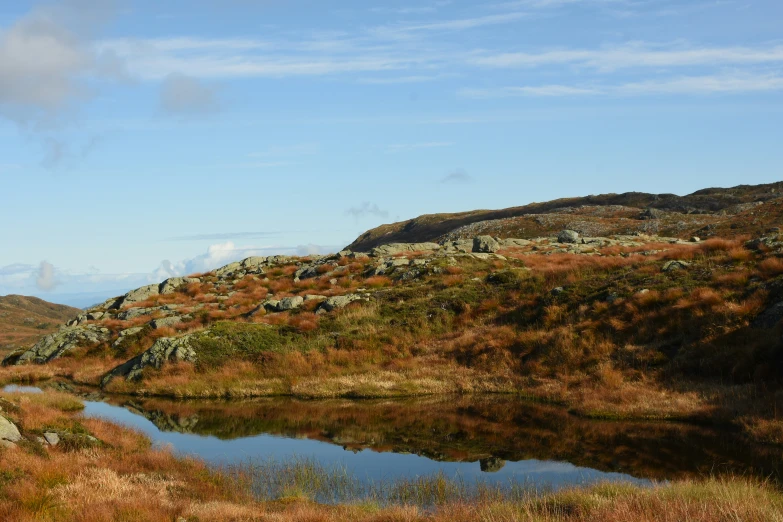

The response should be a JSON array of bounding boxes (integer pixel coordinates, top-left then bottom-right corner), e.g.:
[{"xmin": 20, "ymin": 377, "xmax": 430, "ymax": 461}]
[{"xmin": 3, "ymin": 230, "xmax": 700, "ymax": 385}]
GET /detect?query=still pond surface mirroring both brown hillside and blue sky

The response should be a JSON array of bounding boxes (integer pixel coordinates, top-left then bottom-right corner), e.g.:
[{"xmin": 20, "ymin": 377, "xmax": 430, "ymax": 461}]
[{"xmin": 78, "ymin": 397, "xmax": 781, "ymax": 487}]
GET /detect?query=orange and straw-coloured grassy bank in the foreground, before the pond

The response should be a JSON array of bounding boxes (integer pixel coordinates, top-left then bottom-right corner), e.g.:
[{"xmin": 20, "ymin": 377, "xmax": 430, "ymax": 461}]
[{"xmin": 0, "ymin": 393, "xmax": 783, "ymax": 522}]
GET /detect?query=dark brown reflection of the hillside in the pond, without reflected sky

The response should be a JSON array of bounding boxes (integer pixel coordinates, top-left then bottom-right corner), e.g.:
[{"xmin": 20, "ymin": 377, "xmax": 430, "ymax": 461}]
[{"xmin": 98, "ymin": 396, "xmax": 783, "ymax": 480}]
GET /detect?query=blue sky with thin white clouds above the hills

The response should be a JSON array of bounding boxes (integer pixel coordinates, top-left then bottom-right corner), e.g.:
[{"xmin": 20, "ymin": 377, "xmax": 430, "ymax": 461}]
[{"xmin": 0, "ymin": 0, "xmax": 783, "ymax": 306}]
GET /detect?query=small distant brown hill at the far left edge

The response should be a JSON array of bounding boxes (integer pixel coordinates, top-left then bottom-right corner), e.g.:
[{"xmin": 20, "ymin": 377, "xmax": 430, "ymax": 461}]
[{"xmin": 0, "ymin": 295, "xmax": 80, "ymax": 352}]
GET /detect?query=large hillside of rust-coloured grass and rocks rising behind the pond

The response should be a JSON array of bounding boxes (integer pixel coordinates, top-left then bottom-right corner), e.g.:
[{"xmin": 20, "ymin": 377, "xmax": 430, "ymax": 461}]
[{"xmin": 0, "ymin": 179, "xmax": 783, "ymax": 443}]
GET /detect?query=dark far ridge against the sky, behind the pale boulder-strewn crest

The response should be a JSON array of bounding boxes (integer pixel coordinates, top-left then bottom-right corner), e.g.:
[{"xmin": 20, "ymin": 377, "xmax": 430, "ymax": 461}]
[{"xmin": 347, "ymin": 182, "xmax": 783, "ymax": 251}]
